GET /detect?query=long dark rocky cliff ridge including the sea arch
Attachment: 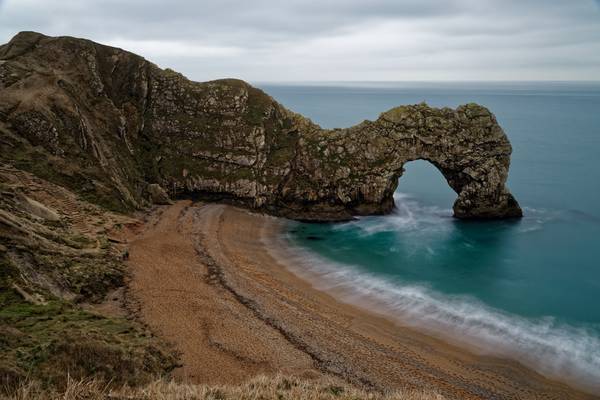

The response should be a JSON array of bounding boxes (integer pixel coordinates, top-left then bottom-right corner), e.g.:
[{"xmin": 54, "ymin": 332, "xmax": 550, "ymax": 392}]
[{"xmin": 0, "ymin": 32, "xmax": 522, "ymax": 220}]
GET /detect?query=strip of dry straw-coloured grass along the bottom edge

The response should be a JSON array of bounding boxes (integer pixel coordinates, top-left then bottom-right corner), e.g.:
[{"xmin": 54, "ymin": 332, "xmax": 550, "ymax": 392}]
[{"xmin": 2, "ymin": 376, "xmax": 444, "ymax": 400}]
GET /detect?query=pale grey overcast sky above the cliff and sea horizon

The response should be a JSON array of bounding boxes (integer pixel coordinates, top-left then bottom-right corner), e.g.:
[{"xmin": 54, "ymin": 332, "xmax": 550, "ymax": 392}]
[{"xmin": 0, "ymin": 0, "xmax": 600, "ymax": 82}]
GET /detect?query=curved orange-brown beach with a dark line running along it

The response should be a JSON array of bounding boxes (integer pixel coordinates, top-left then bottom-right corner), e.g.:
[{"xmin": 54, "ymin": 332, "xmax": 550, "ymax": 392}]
[{"xmin": 127, "ymin": 201, "xmax": 594, "ymax": 399}]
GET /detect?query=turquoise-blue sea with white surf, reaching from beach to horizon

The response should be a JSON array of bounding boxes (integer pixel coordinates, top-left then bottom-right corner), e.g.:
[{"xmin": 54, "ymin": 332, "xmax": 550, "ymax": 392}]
[{"xmin": 259, "ymin": 83, "xmax": 600, "ymax": 391}]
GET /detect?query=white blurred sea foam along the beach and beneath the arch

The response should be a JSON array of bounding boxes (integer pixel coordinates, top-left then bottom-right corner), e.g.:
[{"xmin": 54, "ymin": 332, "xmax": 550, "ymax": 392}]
[{"xmin": 269, "ymin": 205, "xmax": 600, "ymax": 392}]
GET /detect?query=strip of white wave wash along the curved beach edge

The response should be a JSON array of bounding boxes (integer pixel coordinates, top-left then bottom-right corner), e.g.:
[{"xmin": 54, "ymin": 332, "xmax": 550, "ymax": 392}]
[{"xmin": 264, "ymin": 220, "xmax": 600, "ymax": 394}]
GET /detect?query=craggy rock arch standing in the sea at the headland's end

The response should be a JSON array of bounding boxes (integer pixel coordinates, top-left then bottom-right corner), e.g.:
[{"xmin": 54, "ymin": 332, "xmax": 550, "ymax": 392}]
[{"xmin": 274, "ymin": 104, "xmax": 522, "ymax": 219}]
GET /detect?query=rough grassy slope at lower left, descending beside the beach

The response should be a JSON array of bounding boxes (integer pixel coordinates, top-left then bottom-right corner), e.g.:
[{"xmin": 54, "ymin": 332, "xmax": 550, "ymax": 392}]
[{"xmin": 0, "ymin": 165, "xmax": 175, "ymax": 393}]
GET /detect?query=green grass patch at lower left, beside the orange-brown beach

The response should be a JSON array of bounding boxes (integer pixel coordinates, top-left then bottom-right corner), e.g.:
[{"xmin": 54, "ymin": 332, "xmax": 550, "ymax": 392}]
[{"xmin": 0, "ymin": 252, "xmax": 176, "ymax": 393}]
